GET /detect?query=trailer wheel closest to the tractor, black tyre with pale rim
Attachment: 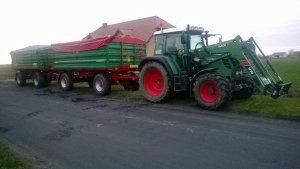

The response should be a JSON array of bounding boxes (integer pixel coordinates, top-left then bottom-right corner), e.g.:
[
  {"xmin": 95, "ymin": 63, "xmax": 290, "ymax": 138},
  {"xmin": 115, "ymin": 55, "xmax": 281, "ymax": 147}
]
[{"xmin": 93, "ymin": 73, "xmax": 111, "ymax": 96}]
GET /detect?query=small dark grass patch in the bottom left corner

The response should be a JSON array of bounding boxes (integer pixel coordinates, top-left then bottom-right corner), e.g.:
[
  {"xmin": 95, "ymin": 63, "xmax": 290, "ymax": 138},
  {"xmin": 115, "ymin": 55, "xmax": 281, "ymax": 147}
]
[{"xmin": 0, "ymin": 143, "xmax": 33, "ymax": 169}]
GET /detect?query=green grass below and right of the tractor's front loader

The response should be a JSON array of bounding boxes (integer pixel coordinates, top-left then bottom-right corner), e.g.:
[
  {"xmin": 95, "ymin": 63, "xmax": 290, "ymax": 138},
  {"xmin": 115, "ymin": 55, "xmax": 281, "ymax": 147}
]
[{"xmin": 226, "ymin": 58, "xmax": 300, "ymax": 120}]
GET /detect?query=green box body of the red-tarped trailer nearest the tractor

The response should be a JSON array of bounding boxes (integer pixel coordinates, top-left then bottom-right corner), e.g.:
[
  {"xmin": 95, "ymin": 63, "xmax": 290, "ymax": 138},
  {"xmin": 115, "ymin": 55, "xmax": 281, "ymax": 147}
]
[{"xmin": 50, "ymin": 41, "xmax": 146, "ymax": 69}]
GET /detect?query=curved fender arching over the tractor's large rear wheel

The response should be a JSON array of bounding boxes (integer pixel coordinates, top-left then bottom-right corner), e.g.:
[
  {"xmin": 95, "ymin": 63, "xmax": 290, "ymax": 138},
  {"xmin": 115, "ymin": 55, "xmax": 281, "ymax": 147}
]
[{"xmin": 138, "ymin": 56, "xmax": 176, "ymax": 77}]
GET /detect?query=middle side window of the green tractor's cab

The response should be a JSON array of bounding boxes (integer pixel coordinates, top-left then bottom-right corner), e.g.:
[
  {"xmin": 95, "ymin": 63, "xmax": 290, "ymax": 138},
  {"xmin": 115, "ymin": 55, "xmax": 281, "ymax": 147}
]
[{"xmin": 166, "ymin": 33, "xmax": 184, "ymax": 54}]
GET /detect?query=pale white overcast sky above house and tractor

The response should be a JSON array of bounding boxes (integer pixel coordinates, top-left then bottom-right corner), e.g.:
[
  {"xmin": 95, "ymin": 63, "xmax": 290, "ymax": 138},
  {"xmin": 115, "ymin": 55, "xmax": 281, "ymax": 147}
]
[{"xmin": 0, "ymin": 0, "xmax": 300, "ymax": 64}]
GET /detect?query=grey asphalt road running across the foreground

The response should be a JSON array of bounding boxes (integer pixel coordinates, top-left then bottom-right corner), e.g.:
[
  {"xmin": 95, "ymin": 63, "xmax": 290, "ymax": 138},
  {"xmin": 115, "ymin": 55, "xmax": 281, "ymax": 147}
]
[{"xmin": 0, "ymin": 82, "xmax": 300, "ymax": 169}]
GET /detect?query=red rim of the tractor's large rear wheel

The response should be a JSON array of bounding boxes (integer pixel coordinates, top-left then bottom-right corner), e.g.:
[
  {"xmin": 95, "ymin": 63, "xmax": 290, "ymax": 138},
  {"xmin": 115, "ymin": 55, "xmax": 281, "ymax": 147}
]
[{"xmin": 144, "ymin": 68, "xmax": 164, "ymax": 96}]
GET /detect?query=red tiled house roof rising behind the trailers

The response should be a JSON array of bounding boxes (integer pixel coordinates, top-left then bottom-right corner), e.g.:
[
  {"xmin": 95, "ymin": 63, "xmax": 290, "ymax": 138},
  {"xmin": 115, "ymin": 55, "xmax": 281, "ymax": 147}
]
[{"xmin": 84, "ymin": 16, "xmax": 174, "ymax": 42}]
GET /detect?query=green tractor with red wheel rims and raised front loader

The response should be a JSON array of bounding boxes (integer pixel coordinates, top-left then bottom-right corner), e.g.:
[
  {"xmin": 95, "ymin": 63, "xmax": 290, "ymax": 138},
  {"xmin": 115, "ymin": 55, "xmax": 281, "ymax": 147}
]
[{"xmin": 139, "ymin": 25, "xmax": 291, "ymax": 110}]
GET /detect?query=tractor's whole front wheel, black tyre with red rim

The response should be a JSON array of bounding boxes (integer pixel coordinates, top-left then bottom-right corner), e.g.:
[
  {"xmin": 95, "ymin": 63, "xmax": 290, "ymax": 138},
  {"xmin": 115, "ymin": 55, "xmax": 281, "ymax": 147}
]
[{"xmin": 193, "ymin": 73, "xmax": 232, "ymax": 110}]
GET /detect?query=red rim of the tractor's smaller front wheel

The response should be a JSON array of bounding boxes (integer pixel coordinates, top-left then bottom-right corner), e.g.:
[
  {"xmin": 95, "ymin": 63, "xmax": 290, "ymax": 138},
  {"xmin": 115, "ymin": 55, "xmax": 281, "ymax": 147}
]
[{"xmin": 199, "ymin": 81, "xmax": 219, "ymax": 103}]
